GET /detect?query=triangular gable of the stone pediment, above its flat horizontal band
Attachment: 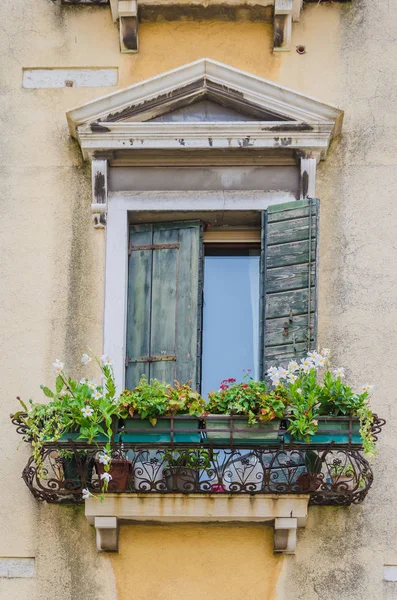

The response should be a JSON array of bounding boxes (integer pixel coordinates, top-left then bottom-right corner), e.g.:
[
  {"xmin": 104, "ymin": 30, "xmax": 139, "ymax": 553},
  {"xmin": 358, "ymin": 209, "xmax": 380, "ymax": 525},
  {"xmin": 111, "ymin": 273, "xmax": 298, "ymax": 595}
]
[{"xmin": 67, "ymin": 59, "xmax": 343, "ymax": 137}]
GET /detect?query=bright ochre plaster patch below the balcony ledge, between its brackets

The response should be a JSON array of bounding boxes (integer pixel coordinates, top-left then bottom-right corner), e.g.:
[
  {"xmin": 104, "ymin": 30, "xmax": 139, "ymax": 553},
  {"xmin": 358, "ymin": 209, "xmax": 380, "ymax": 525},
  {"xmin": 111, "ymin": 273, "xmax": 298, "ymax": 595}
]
[{"xmin": 111, "ymin": 525, "xmax": 283, "ymax": 600}]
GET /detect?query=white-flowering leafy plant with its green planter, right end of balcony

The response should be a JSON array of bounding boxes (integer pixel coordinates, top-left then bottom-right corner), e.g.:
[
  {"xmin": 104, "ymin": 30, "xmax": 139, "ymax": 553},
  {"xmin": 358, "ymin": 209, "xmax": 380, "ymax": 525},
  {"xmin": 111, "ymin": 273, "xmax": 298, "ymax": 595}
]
[{"xmin": 268, "ymin": 351, "xmax": 375, "ymax": 454}]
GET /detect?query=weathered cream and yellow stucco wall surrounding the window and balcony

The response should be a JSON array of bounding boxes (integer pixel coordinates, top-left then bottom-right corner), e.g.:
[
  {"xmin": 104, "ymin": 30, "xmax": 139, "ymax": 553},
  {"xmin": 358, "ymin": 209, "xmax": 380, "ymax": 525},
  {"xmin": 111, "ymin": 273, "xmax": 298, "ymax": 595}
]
[{"xmin": 0, "ymin": 0, "xmax": 397, "ymax": 600}]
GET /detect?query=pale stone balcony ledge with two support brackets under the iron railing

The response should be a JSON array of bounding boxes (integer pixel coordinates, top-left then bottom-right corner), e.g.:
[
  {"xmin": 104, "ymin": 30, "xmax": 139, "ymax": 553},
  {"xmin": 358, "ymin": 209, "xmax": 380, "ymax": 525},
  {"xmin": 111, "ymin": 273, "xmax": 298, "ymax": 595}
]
[{"xmin": 85, "ymin": 493, "xmax": 310, "ymax": 554}]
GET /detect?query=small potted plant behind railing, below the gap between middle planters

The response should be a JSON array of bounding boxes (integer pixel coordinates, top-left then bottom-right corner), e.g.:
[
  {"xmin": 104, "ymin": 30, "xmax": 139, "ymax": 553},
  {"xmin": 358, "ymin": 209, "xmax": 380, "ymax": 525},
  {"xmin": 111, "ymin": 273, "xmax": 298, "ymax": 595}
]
[{"xmin": 164, "ymin": 448, "xmax": 211, "ymax": 493}]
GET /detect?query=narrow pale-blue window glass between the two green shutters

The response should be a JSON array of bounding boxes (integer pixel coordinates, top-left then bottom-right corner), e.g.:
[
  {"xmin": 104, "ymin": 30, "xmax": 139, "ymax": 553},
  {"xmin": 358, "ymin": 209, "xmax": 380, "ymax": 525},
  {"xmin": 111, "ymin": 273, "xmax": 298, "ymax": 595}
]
[{"xmin": 201, "ymin": 246, "xmax": 260, "ymax": 397}]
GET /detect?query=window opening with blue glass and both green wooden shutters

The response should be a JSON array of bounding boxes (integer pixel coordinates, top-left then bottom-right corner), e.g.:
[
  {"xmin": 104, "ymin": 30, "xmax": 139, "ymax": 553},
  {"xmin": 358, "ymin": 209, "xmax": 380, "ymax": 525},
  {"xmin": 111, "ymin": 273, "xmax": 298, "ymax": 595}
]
[{"xmin": 126, "ymin": 200, "xmax": 318, "ymax": 393}]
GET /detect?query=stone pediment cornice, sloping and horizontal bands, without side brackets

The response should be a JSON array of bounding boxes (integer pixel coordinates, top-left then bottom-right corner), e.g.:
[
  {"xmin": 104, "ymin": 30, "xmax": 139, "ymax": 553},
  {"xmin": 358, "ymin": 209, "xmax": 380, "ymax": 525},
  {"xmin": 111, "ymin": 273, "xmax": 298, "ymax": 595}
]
[{"xmin": 67, "ymin": 59, "xmax": 343, "ymax": 159}]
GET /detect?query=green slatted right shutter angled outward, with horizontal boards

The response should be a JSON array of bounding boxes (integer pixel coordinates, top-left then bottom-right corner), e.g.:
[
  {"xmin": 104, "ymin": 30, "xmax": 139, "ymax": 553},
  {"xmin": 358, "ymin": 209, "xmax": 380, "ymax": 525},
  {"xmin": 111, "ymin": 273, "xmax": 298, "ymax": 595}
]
[{"xmin": 260, "ymin": 198, "xmax": 319, "ymax": 377}]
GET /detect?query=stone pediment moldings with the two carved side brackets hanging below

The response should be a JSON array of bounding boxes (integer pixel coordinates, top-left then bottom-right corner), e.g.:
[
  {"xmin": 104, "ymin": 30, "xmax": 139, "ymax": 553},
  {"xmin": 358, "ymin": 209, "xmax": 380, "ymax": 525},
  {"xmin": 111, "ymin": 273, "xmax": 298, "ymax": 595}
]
[{"xmin": 67, "ymin": 59, "xmax": 343, "ymax": 228}]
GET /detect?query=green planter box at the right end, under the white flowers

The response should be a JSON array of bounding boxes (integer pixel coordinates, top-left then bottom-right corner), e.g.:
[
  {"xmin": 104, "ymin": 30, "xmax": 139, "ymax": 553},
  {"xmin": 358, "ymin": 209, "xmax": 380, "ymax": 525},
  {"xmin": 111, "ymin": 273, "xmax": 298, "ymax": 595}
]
[{"xmin": 284, "ymin": 417, "xmax": 363, "ymax": 446}]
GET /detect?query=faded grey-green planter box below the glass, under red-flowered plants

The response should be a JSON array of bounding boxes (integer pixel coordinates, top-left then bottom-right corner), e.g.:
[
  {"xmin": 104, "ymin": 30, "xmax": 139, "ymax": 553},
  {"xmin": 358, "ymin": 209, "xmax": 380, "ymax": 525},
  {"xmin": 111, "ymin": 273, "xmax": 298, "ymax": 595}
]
[{"xmin": 205, "ymin": 415, "xmax": 280, "ymax": 445}]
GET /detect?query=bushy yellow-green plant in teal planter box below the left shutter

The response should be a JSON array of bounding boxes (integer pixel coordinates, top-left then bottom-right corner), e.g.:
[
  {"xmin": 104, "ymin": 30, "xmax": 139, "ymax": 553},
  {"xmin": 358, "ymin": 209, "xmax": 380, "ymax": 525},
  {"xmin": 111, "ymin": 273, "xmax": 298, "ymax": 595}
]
[{"xmin": 120, "ymin": 375, "xmax": 205, "ymax": 443}]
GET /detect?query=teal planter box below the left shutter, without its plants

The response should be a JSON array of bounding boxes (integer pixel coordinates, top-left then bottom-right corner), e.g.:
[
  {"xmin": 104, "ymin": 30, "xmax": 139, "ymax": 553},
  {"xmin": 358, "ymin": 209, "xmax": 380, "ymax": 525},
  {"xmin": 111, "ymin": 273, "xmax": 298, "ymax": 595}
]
[{"xmin": 120, "ymin": 417, "xmax": 201, "ymax": 444}]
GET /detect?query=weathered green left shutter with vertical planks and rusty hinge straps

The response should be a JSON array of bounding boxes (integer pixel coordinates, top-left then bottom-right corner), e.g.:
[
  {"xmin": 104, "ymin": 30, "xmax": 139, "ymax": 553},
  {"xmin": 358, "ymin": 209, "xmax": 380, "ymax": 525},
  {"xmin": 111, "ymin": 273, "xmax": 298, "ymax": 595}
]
[{"xmin": 126, "ymin": 221, "xmax": 203, "ymax": 389}]
